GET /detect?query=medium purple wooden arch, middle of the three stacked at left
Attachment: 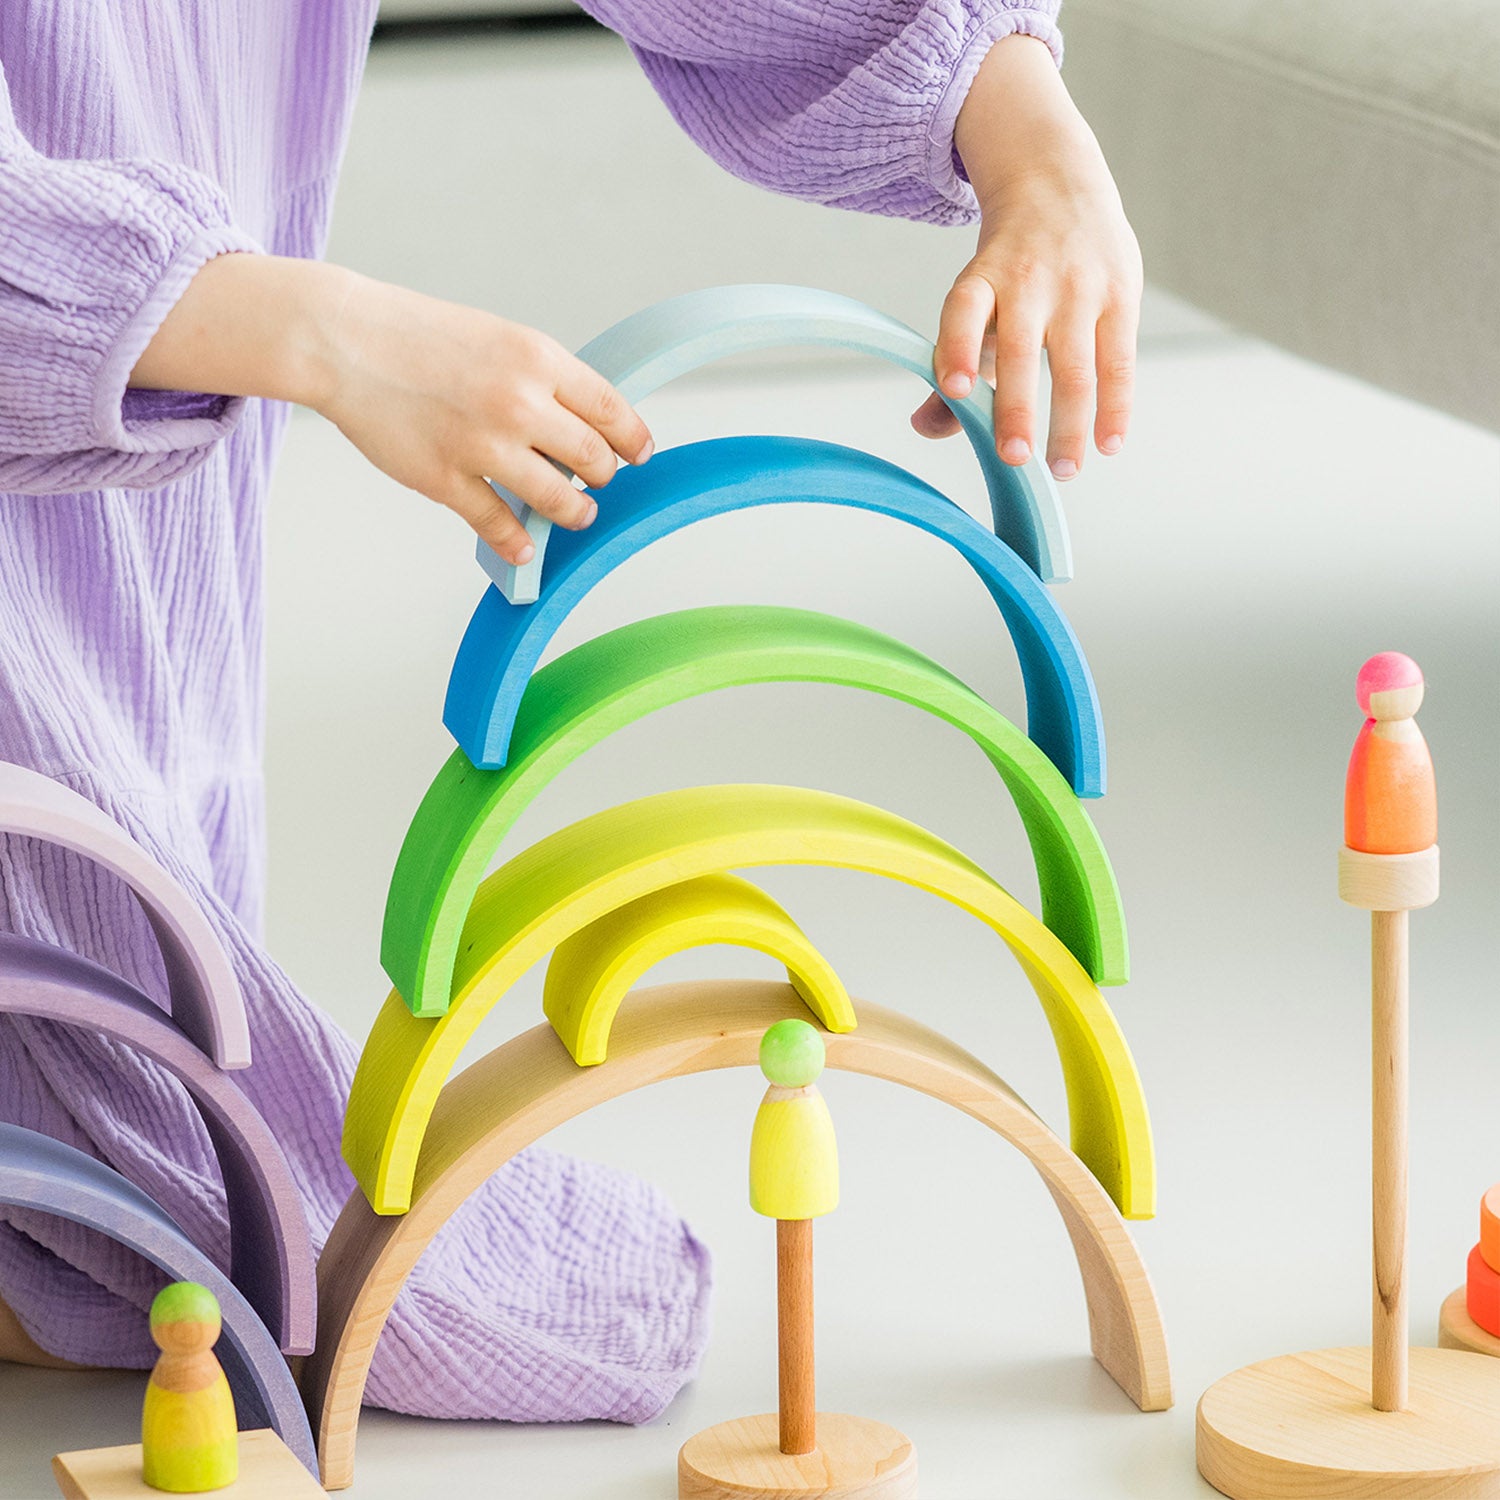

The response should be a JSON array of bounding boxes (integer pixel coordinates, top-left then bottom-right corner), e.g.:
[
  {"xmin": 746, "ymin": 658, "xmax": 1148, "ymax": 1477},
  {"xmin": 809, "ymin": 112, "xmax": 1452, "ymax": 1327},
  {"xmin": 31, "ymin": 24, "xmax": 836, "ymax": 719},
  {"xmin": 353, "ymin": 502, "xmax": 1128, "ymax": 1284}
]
[{"xmin": 0, "ymin": 933, "xmax": 317, "ymax": 1355}]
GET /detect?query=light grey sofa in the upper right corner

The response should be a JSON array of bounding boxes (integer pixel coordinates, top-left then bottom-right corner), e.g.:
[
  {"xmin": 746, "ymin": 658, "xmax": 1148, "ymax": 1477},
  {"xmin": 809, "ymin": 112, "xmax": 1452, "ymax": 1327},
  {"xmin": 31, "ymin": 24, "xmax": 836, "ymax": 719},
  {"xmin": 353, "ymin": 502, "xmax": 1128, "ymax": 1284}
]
[{"xmin": 1062, "ymin": 0, "xmax": 1500, "ymax": 431}]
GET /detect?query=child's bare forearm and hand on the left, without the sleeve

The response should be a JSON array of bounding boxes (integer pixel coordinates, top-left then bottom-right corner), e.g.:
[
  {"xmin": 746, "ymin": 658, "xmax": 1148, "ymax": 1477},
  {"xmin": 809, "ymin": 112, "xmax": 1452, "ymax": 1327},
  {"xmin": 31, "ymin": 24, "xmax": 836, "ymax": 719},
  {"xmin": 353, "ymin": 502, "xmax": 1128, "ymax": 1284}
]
[{"xmin": 131, "ymin": 255, "xmax": 651, "ymax": 564}]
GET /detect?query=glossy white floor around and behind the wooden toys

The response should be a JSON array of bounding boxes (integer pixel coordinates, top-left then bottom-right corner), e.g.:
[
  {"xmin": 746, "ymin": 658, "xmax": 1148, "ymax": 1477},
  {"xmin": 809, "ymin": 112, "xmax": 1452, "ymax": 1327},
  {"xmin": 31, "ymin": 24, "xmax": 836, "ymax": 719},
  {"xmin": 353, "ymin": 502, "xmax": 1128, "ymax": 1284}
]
[{"xmin": 0, "ymin": 20, "xmax": 1500, "ymax": 1500}]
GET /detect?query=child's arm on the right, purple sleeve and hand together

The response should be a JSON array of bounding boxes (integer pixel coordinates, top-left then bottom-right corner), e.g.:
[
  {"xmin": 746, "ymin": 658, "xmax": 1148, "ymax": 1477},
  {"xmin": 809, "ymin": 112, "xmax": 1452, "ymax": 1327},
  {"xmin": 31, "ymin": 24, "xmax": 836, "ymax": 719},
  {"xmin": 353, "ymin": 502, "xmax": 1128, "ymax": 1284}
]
[{"xmin": 581, "ymin": 0, "xmax": 1140, "ymax": 477}]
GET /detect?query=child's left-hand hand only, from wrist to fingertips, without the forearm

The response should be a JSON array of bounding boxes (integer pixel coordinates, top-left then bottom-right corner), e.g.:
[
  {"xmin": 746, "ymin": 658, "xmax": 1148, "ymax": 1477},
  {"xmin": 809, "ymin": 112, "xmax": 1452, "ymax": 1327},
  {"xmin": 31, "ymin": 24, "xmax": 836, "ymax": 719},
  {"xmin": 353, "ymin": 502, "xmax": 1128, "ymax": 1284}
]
[{"xmin": 312, "ymin": 276, "xmax": 651, "ymax": 564}]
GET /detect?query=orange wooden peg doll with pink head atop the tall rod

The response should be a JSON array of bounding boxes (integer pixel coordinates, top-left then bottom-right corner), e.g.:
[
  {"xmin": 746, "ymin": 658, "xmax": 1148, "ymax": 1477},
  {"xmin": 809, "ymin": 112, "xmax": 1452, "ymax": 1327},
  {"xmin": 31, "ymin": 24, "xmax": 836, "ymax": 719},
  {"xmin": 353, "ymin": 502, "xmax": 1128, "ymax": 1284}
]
[{"xmin": 1344, "ymin": 651, "xmax": 1437, "ymax": 854}]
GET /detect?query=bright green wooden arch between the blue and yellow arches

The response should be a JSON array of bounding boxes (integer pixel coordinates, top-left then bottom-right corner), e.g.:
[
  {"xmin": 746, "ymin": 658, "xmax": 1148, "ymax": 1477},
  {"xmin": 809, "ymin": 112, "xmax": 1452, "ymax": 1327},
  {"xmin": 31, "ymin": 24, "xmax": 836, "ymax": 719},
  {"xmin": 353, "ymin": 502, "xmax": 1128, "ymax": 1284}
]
[{"xmin": 381, "ymin": 605, "xmax": 1130, "ymax": 1016}]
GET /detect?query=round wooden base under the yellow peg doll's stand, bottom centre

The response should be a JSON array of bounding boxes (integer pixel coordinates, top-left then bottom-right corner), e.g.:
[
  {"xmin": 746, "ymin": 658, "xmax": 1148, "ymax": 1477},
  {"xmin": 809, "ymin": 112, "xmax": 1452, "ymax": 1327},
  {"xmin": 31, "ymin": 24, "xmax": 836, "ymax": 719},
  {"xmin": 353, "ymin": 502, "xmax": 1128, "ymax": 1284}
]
[{"xmin": 677, "ymin": 1412, "xmax": 917, "ymax": 1500}]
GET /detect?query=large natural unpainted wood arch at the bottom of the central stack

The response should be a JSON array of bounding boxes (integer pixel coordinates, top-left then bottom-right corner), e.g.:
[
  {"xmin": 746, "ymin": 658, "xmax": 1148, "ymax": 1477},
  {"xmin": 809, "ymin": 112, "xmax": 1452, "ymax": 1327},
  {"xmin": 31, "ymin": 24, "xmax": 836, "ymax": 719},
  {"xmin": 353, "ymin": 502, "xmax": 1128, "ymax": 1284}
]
[{"xmin": 302, "ymin": 980, "xmax": 1172, "ymax": 1490}]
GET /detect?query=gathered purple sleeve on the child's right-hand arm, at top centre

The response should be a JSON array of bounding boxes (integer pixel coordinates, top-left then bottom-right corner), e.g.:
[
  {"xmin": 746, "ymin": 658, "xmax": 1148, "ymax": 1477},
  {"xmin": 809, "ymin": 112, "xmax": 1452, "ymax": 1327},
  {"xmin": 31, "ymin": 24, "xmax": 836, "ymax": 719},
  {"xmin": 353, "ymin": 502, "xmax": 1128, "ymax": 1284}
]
[{"xmin": 581, "ymin": 0, "xmax": 1062, "ymax": 224}]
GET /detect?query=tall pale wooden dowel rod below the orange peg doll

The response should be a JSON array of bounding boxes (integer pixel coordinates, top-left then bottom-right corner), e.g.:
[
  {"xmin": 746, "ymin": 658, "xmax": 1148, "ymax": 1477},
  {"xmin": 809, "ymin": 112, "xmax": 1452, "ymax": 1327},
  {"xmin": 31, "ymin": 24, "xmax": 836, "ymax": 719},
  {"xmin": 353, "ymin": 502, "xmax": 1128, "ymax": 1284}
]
[{"xmin": 1370, "ymin": 912, "xmax": 1409, "ymax": 1412}]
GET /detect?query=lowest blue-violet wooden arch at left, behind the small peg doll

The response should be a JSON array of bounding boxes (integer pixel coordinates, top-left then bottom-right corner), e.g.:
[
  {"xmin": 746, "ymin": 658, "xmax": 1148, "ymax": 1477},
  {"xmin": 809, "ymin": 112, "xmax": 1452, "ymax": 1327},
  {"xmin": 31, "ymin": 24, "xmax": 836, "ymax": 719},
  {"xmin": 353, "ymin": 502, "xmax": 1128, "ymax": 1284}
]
[{"xmin": 0, "ymin": 1125, "xmax": 318, "ymax": 1475}]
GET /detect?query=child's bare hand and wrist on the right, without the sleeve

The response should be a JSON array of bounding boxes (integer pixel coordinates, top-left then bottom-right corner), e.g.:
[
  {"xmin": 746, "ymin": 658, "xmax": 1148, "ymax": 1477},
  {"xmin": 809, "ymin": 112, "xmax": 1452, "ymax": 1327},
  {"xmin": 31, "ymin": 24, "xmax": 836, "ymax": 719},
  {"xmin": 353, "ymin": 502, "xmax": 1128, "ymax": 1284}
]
[{"xmin": 912, "ymin": 36, "xmax": 1142, "ymax": 480}]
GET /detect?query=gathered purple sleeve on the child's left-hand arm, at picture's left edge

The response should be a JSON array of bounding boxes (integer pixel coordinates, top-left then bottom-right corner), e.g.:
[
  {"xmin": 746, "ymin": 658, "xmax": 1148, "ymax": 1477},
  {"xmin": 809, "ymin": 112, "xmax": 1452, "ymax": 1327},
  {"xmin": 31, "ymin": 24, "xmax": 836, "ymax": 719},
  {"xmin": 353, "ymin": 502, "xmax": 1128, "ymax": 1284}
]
[{"xmin": 0, "ymin": 75, "xmax": 257, "ymax": 494}]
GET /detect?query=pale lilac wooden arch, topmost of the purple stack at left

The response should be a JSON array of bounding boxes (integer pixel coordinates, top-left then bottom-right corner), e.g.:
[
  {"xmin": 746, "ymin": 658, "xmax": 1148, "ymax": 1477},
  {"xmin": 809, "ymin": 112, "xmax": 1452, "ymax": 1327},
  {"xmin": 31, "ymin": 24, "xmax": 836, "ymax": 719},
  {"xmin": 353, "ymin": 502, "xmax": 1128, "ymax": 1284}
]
[{"xmin": 0, "ymin": 762, "xmax": 251, "ymax": 1068}]
